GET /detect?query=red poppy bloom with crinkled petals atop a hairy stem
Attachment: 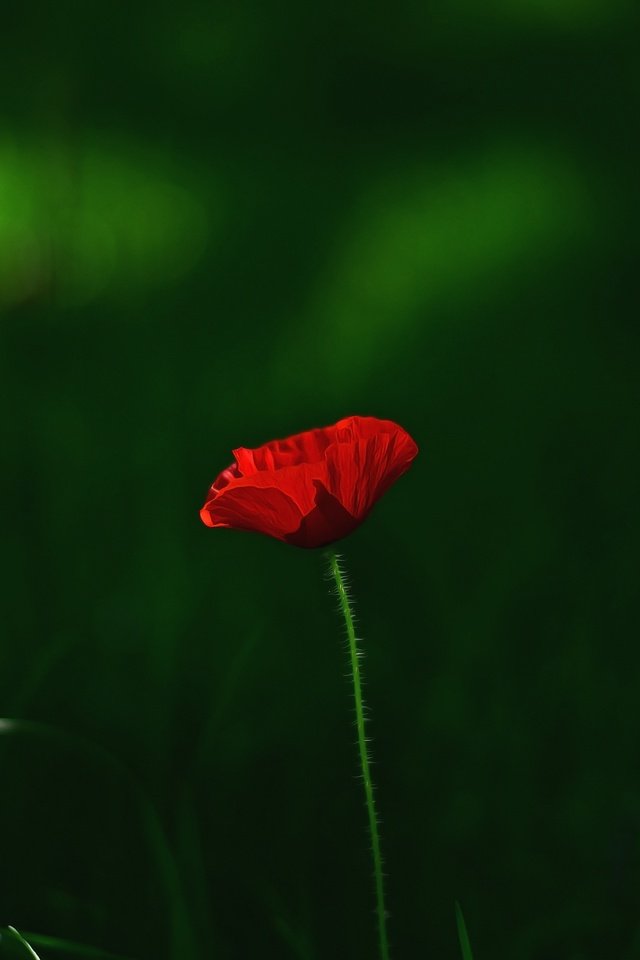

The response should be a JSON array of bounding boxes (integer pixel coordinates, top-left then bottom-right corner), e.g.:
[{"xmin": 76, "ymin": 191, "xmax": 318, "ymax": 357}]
[{"xmin": 200, "ymin": 417, "xmax": 418, "ymax": 547}]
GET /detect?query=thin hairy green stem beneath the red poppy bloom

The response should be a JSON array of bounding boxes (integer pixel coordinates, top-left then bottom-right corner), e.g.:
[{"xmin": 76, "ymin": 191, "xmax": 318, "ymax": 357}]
[{"xmin": 327, "ymin": 550, "xmax": 389, "ymax": 960}]
